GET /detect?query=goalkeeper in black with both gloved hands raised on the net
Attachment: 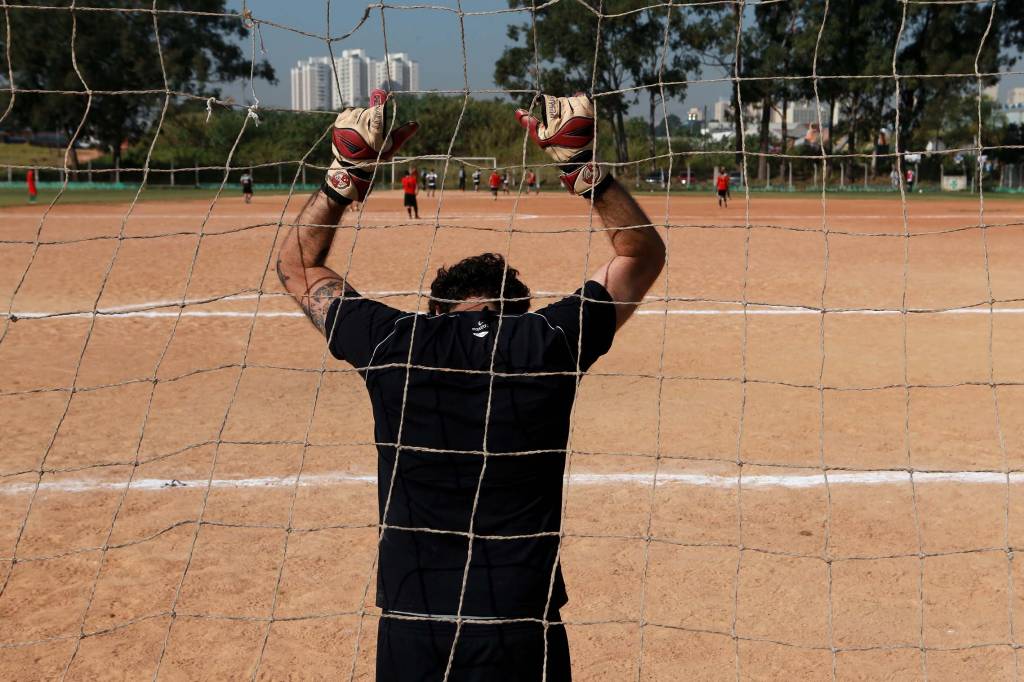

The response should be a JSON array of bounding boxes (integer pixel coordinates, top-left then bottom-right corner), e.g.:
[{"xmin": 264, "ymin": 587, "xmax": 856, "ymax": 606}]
[{"xmin": 278, "ymin": 91, "xmax": 665, "ymax": 681}]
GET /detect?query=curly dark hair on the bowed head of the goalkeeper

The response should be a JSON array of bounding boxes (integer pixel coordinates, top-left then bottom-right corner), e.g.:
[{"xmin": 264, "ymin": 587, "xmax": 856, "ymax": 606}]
[{"xmin": 430, "ymin": 253, "xmax": 529, "ymax": 314}]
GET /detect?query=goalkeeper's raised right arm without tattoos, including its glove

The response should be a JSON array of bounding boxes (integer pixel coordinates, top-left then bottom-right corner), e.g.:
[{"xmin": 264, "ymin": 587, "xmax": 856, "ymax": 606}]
[{"xmin": 516, "ymin": 94, "xmax": 665, "ymax": 328}]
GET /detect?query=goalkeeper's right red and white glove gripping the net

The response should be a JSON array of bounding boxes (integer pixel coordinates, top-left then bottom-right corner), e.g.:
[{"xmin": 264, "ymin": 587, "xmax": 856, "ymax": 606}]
[{"xmin": 515, "ymin": 93, "xmax": 611, "ymax": 198}]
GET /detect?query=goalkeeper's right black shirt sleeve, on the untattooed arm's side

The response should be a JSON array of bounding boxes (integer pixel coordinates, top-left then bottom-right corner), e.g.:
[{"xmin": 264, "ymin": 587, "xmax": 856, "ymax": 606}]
[{"xmin": 537, "ymin": 281, "xmax": 615, "ymax": 372}]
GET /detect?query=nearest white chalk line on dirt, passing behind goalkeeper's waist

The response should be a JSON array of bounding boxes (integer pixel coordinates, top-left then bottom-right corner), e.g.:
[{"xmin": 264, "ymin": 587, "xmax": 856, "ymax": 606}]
[{"xmin": 0, "ymin": 470, "xmax": 1024, "ymax": 496}]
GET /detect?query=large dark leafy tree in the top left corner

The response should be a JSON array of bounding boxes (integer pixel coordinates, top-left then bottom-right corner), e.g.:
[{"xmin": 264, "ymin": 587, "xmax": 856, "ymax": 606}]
[{"xmin": 0, "ymin": 0, "xmax": 274, "ymax": 166}]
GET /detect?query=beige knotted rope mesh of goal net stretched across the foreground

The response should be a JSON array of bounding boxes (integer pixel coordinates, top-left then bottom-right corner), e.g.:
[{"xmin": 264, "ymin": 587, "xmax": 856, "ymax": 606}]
[{"xmin": 0, "ymin": 0, "xmax": 1024, "ymax": 680}]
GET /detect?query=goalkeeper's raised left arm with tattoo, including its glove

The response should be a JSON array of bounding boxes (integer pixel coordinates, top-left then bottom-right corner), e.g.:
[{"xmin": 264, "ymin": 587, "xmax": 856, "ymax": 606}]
[{"xmin": 278, "ymin": 90, "xmax": 419, "ymax": 332}]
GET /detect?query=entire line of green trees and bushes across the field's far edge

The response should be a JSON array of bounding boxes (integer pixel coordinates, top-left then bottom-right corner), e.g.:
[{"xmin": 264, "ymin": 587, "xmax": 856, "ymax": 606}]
[{"xmin": 0, "ymin": 0, "xmax": 1024, "ymax": 187}]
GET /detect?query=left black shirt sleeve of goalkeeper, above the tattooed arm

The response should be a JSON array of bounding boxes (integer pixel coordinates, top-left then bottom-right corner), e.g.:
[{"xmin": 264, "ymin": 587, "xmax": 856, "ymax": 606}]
[{"xmin": 325, "ymin": 292, "xmax": 404, "ymax": 369}]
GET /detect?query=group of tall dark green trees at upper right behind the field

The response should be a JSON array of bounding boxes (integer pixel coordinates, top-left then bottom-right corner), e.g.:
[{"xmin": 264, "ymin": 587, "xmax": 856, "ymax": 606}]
[{"xmin": 495, "ymin": 0, "xmax": 1024, "ymax": 178}]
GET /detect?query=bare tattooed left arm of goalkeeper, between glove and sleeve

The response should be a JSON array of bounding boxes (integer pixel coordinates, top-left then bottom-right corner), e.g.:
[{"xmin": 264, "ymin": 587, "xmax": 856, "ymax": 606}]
[{"xmin": 276, "ymin": 190, "xmax": 347, "ymax": 331}]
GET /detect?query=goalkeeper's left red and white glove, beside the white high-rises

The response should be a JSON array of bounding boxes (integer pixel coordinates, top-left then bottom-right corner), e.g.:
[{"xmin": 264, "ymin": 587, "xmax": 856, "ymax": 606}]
[{"xmin": 322, "ymin": 90, "xmax": 420, "ymax": 206}]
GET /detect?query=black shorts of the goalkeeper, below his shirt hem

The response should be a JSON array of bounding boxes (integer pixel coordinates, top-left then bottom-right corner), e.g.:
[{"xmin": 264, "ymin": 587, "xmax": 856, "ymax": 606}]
[{"xmin": 377, "ymin": 615, "xmax": 572, "ymax": 682}]
